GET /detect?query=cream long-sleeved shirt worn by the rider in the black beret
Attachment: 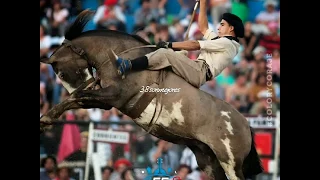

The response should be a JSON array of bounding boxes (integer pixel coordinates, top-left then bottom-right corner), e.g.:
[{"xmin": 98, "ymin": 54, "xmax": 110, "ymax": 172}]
[{"xmin": 197, "ymin": 29, "xmax": 240, "ymax": 77}]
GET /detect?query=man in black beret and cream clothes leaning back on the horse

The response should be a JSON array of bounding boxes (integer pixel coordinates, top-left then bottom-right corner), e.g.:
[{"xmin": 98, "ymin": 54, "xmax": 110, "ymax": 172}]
[{"xmin": 109, "ymin": 0, "xmax": 244, "ymax": 88}]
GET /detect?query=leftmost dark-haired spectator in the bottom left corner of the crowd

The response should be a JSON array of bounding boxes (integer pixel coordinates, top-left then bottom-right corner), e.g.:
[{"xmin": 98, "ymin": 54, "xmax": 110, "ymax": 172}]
[{"xmin": 40, "ymin": 156, "xmax": 57, "ymax": 180}]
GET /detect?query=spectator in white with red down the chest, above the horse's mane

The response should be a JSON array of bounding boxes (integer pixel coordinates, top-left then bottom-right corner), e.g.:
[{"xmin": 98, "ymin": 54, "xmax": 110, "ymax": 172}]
[{"xmin": 93, "ymin": 0, "xmax": 126, "ymax": 31}]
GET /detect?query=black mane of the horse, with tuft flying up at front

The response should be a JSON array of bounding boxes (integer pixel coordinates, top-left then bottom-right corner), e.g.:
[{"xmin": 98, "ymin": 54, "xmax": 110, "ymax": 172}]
[{"xmin": 65, "ymin": 10, "xmax": 150, "ymax": 45}]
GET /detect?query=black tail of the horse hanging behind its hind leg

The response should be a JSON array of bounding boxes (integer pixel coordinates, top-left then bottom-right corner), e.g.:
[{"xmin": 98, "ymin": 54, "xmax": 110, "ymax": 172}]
[{"xmin": 243, "ymin": 127, "xmax": 263, "ymax": 178}]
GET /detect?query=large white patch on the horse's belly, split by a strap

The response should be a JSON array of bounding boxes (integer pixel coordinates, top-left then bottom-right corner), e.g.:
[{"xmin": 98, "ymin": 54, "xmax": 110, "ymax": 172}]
[{"xmin": 136, "ymin": 98, "xmax": 184, "ymax": 127}]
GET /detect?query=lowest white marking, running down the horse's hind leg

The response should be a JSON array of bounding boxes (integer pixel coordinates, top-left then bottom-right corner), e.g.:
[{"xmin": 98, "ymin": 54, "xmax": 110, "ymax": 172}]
[{"xmin": 219, "ymin": 137, "xmax": 239, "ymax": 180}]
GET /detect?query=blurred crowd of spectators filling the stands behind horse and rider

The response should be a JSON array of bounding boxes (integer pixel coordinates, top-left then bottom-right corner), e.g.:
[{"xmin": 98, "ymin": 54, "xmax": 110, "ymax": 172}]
[{"xmin": 40, "ymin": 0, "xmax": 280, "ymax": 180}]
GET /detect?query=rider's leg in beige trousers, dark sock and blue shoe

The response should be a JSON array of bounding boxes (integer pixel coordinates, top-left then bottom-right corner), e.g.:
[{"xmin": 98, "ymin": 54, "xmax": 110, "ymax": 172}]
[{"xmin": 109, "ymin": 48, "xmax": 211, "ymax": 87}]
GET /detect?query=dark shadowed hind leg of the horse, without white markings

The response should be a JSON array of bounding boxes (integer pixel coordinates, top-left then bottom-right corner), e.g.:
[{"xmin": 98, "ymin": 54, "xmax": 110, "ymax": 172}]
[{"xmin": 188, "ymin": 142, "xmax": 227, "ymax": 180}]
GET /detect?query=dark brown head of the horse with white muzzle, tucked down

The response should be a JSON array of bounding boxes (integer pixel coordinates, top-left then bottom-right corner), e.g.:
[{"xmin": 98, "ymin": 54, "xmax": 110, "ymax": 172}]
[{"xmin": 40, "ymin": 40, "xmax": 94, "ymax": 94}]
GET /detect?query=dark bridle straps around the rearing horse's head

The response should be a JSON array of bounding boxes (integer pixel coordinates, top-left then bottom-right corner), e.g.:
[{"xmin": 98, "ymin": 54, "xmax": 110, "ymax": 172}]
[{"xmin": 62, "ymin": 39, "xmax": 95, "ymax": 94}]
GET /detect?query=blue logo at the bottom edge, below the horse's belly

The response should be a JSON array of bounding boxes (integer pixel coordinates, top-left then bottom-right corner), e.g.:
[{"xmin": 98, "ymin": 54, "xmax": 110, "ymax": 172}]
[{"xmin": 142, "ymin": 158, "xmax": 180, "ymax": 180}]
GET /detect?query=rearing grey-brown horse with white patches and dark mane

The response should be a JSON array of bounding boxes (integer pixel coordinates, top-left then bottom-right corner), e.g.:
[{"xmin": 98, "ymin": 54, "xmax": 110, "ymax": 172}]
[{"xmin": 40, "ymin": 10, "xmax": 263, "ymax": 180}]
